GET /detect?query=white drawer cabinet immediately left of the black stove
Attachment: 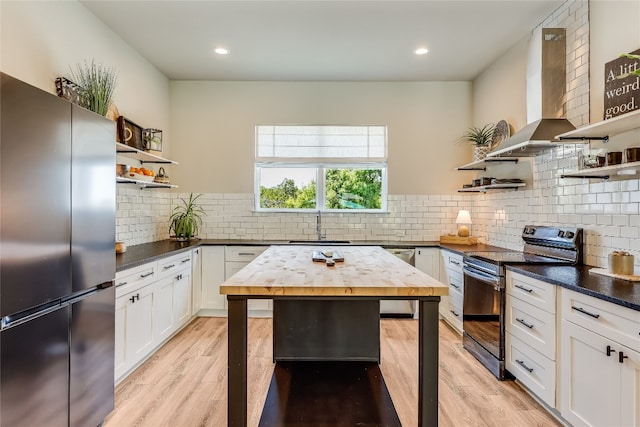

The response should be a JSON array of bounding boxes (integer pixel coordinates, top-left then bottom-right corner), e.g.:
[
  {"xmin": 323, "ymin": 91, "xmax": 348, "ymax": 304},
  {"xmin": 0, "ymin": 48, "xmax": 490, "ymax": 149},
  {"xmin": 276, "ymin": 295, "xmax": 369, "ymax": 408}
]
[{"xmin": 439, "ymin": 249, "xmax": 464, "ymax": 333}]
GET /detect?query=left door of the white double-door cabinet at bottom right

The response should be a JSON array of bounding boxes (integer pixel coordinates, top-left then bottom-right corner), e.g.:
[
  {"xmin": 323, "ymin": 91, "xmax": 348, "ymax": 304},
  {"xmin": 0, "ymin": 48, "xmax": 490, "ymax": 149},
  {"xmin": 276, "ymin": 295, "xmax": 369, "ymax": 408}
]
[{"xmin": 559, "ymin": 319, "xmax": 620, "ymax": 426}]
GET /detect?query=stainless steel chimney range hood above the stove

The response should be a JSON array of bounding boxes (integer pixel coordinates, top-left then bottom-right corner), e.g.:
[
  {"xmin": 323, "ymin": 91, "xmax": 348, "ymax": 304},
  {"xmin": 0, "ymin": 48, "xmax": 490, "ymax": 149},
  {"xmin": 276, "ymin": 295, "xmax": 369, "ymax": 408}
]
[{"xmin": 488, "ymin": 28, "xmax": 575, "ymax": 157}]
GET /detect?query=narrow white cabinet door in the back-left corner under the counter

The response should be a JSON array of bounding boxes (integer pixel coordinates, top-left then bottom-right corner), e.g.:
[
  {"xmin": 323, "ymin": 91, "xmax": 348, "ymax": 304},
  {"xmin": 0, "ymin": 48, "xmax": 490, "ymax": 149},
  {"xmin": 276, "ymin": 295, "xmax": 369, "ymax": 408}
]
[{"xmin": 201, "ymin": 246, "xmax": 227, "ymax": 310}]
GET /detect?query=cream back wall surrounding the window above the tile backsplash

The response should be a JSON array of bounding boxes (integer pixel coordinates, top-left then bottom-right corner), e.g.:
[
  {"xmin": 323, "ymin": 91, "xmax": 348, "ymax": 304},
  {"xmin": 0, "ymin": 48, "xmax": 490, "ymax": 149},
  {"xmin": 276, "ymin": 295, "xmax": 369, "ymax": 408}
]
[{"xmin": 171, "ymin": 81, "xmax": 471, "ymax": 194}]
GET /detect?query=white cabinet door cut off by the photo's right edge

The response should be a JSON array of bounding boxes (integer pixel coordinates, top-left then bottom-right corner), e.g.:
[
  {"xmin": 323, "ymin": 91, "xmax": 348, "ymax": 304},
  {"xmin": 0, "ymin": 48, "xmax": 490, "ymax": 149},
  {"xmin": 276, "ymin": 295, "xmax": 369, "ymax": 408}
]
[{"xmin": 618, "ymin": 346, "xmax": 640, "ymax": 426}]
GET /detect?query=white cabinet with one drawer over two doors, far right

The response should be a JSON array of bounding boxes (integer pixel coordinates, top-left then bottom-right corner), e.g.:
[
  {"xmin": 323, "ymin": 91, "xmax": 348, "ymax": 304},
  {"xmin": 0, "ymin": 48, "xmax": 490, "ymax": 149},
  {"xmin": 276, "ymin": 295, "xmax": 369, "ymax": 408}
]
[{"xmin": 560, "ymin": 289, "xmax": 640, "ymax": 427}]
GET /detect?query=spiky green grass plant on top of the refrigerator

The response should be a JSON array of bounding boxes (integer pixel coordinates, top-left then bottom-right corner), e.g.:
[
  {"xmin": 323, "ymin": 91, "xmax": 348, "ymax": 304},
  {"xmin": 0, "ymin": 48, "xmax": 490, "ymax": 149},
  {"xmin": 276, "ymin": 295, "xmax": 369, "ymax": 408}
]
[{"xmin": 71, "ymin": 60, "xmax": 118, "ymax": 117}]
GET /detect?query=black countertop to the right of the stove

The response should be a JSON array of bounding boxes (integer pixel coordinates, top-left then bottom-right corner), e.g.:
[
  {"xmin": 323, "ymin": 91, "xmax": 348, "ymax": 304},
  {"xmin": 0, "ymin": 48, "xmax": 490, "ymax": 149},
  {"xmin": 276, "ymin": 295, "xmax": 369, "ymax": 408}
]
[{"xmin": 506, "ymin": 265, "xmax": 640, "ymax": 311}]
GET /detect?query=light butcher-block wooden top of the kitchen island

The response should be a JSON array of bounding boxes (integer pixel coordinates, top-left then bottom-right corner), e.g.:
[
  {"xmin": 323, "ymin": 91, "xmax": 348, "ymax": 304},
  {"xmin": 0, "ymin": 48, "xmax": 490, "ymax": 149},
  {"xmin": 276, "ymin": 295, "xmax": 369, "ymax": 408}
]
[{"xmin": 220, "ymin": 245, "xmax": 449, "ymax": 299}]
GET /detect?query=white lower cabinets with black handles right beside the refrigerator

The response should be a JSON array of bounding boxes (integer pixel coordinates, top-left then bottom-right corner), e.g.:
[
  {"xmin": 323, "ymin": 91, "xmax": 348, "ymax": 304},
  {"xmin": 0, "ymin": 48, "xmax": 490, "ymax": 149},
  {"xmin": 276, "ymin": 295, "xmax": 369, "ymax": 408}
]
[{"xmin": 115, "ymin": 252, "xmax": 192, "ymax": 382}]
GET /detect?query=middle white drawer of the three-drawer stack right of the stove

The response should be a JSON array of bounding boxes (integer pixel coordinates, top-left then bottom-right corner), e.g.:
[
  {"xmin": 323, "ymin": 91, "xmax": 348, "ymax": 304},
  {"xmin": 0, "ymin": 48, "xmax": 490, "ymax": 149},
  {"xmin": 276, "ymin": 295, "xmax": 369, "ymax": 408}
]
[{"xmin": 505, "ymin": 294, "xmax": 556, "ymax": 360}]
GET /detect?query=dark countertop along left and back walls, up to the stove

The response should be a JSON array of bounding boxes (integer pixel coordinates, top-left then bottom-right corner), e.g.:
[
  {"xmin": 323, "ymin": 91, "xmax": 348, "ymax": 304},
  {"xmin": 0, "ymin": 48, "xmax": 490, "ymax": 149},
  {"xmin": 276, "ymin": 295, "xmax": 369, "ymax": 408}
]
[{"xmin": 116, "ymin": 239, "xmax": 505, "ymax": 271}]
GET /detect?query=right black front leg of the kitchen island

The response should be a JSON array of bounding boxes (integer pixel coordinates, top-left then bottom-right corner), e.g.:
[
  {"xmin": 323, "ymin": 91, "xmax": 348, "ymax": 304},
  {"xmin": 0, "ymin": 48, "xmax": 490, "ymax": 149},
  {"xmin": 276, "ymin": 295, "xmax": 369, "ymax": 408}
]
[{"xmin": 418, "ymin": 297, "xmax": 440, "ymax": 427}]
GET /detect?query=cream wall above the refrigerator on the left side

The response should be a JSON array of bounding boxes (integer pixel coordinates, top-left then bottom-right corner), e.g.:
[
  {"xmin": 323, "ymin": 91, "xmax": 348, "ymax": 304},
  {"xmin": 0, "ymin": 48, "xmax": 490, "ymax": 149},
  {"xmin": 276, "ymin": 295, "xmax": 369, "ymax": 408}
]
[{"xmin": 0, "ymin": 0, "xmax": 171, "ymax": 155}]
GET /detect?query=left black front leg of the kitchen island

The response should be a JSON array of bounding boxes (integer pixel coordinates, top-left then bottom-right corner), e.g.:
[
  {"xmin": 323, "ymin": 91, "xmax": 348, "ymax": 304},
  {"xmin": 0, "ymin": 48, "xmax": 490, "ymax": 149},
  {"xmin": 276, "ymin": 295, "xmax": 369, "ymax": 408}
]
[{"xmin": 227, "ymin": 297, "xmax": 247, "ymax": 427}]
